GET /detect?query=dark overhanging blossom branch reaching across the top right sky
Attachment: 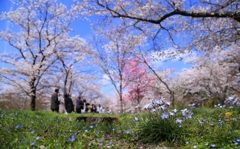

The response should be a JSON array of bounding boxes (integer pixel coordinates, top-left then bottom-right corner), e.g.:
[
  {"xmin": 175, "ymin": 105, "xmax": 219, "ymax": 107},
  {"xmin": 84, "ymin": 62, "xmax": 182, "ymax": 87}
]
[{"xmin": 79, "ymin": 0, "xmax": 240, "ymax": 51}]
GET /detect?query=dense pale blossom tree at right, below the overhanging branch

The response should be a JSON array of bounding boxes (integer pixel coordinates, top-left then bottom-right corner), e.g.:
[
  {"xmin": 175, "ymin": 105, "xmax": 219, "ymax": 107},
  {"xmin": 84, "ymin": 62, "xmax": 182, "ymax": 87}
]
[{"xmin": 178, "ymin": 46, "xmax": 239, "ymax": 104}]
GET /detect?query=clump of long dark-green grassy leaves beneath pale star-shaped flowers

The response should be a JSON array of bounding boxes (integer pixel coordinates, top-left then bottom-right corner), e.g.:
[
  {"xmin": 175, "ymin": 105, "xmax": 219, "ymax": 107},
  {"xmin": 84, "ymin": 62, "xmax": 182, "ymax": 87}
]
[{"xmin": 137, "ymin": 113, "xmax": 187, "ymax": 145}]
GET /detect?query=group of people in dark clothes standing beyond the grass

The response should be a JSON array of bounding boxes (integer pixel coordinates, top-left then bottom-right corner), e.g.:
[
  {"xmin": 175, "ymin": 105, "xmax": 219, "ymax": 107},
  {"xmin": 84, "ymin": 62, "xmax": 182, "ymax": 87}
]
[{"xmin": 51, "ymin": 89, "xmax": 112, "ymax": 114}]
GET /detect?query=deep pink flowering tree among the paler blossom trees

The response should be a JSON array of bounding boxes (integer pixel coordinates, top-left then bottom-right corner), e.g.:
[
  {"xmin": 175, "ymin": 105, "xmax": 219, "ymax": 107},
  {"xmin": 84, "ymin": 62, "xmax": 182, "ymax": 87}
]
[{"xmin": 123, "ymin": 58, "xmax": 153, "ymax": 105}]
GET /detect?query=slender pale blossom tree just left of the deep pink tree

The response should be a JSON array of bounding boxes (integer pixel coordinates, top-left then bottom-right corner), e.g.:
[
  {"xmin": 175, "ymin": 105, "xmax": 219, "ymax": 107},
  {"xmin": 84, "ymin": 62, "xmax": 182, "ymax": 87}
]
[{"xmin": 92, "ymin": 26, "xmax": 143, "ymax": 112}]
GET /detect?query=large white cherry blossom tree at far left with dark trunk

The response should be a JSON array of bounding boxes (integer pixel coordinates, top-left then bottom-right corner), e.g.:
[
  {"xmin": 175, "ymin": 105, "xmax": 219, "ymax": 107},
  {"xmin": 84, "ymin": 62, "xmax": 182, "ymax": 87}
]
[{"xmin": 0, "ymin": 0, "xmax": 83, "ymax": 111}]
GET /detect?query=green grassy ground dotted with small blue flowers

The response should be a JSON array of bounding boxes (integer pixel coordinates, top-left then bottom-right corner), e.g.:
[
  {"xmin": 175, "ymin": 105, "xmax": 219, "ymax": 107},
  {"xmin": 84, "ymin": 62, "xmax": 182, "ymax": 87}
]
[{"xmin": 0, "ymin": 107, "xmax": 240, "ymax": 149}]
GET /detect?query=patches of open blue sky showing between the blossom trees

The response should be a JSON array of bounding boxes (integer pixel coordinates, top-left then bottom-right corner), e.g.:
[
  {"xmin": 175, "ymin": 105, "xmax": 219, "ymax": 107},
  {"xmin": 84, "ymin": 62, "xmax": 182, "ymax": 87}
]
[{"xmin": 0, "ymin": 0, "xmax": 191, "ymax": 96}]
